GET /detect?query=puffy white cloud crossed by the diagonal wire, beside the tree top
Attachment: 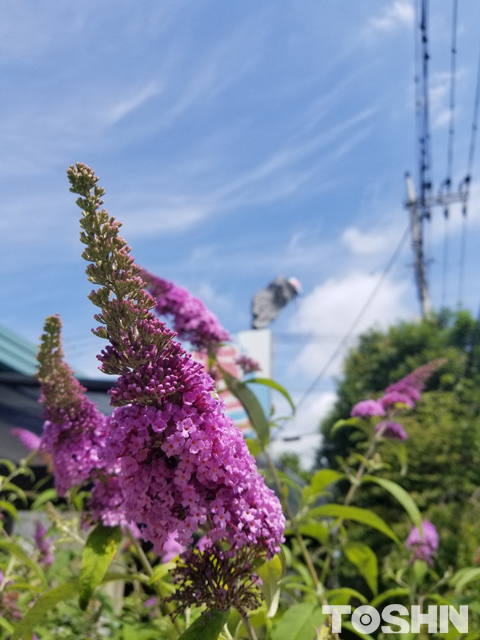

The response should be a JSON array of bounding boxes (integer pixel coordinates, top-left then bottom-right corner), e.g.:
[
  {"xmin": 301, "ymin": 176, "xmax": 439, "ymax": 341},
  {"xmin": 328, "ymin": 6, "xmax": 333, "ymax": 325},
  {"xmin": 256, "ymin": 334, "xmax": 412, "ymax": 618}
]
[{"xmin": 292, "ymin": 272, "xmax": 409, "ymax": 377}]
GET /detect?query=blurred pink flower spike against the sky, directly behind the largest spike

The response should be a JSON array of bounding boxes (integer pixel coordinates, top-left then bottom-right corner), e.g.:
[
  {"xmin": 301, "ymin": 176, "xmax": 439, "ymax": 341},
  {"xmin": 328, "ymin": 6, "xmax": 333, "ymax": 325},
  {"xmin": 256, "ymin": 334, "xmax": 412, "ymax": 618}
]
[{"xmin": 141, "ymin": 270, "xmax": 232, "ymax": 350}]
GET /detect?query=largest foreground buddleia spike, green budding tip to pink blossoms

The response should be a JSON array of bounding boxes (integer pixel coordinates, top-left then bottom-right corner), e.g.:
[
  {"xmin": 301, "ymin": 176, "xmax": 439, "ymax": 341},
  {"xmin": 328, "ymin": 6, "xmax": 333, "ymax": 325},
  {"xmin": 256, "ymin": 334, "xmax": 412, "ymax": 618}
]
[{"xmin": 67, "ymin": 164, "xmax": 285, "ymax": 606}]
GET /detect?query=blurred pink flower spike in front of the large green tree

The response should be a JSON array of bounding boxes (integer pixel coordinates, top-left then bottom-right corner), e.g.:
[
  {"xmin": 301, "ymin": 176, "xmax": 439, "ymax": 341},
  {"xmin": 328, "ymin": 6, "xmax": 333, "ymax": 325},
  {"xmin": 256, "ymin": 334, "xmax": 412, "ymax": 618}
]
[{"xmin": 350, "ymin": 358, "xmax": 445, "ymax": 440}]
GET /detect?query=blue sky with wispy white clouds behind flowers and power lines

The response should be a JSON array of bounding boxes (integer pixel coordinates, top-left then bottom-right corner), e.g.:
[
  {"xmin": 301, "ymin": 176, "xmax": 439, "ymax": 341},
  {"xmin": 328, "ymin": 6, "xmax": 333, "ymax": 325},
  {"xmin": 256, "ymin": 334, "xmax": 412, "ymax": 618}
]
[{"xmin": 0, "ymin": 0, "xmax": 480, "ymax": 460}]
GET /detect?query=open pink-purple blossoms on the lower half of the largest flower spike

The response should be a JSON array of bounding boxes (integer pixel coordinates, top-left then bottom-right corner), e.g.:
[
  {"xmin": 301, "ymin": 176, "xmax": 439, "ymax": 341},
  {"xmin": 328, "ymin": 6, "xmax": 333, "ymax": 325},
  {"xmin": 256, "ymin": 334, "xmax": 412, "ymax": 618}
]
[{"xmin": 104, "ymin": 356, "xmax": 285, "ymax": 556}]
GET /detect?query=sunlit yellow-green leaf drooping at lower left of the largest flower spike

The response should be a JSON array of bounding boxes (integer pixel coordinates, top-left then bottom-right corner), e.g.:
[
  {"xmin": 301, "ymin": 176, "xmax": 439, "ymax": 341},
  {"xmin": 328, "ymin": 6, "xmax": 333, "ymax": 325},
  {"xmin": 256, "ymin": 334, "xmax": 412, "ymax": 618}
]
[{"xmin": 79, "ymin": 524, "xmax": 122, "ymax": 611}]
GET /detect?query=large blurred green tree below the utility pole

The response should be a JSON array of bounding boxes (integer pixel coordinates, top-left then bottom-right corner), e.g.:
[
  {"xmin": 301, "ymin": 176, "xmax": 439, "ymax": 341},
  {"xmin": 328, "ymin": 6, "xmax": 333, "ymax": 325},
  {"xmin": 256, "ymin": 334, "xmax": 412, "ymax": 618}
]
[{"xmin": 317, "ymin": 310, "xmax": 480, "ymax": 573}]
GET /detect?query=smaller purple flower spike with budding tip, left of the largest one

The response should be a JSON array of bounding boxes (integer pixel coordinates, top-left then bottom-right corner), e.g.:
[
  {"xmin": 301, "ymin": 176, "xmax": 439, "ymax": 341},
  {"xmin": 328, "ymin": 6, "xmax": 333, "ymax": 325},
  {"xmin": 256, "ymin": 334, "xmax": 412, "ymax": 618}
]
[{"xmin": 37, "ymin": 315, "xmax": 131, "ymax": 526}]
